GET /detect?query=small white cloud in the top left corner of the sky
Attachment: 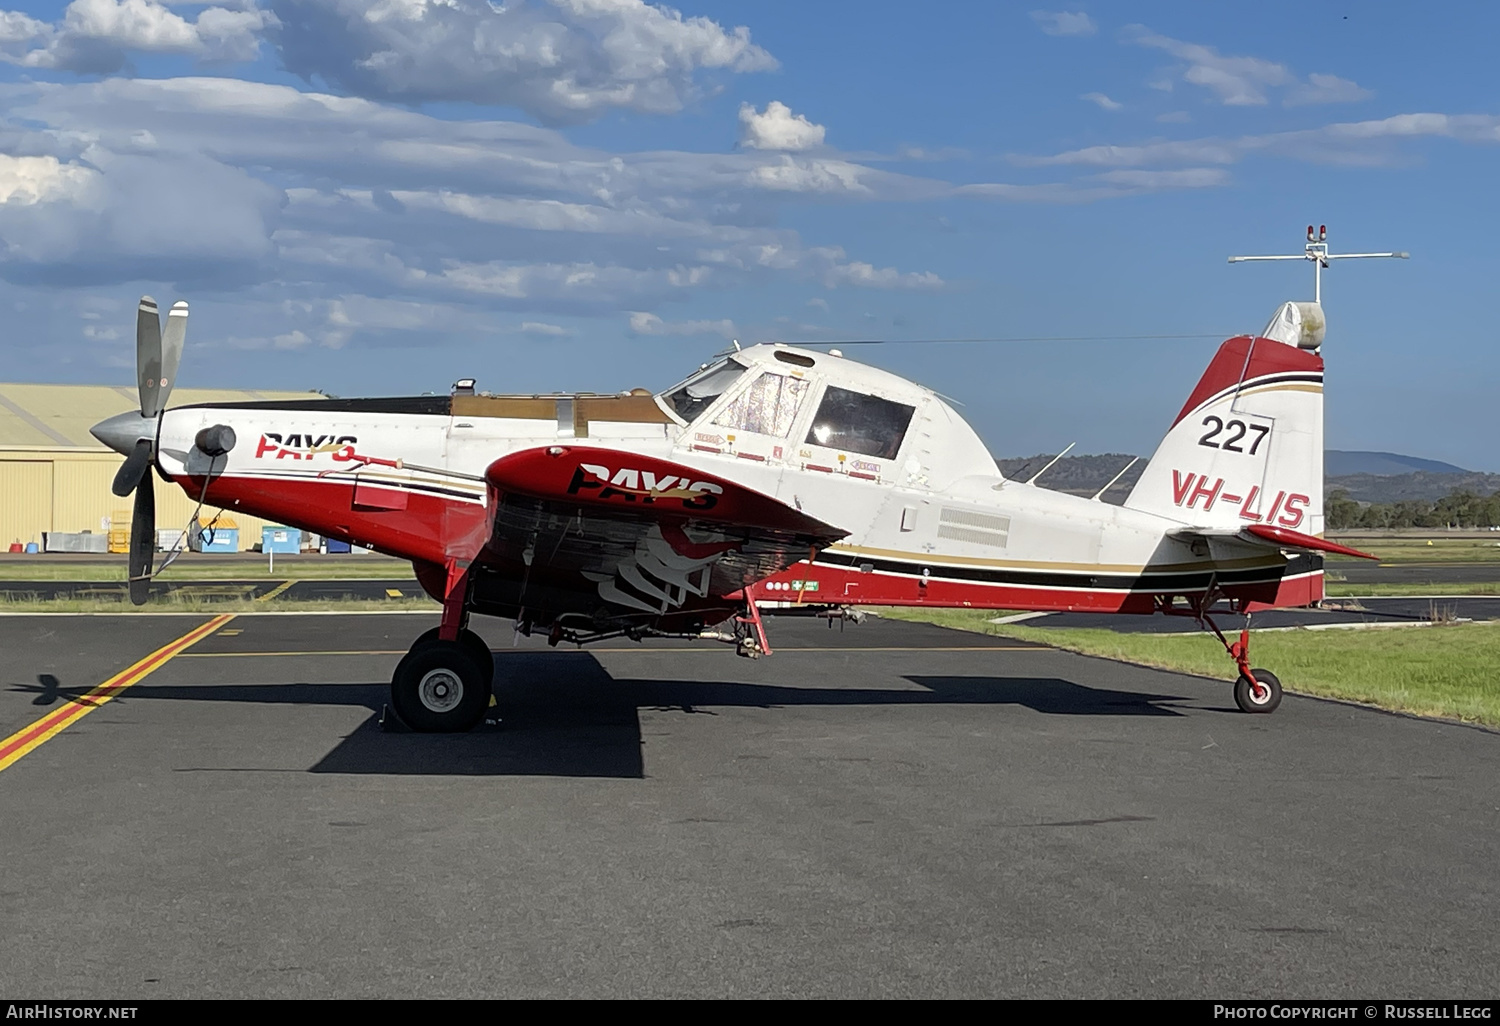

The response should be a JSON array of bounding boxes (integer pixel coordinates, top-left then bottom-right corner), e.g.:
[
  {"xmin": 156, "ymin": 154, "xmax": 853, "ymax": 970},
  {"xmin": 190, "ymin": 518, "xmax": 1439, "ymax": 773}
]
[{"xmin": 0, "ymin": 0, "xmax": 276, "ymax": 74}]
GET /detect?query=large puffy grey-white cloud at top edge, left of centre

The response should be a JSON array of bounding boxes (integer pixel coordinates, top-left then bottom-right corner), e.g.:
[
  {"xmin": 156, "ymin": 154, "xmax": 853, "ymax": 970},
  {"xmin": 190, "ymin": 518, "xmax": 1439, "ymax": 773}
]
[{"xmin": 272, "ymin": 0, "xmax": 777, "ymax": 125}]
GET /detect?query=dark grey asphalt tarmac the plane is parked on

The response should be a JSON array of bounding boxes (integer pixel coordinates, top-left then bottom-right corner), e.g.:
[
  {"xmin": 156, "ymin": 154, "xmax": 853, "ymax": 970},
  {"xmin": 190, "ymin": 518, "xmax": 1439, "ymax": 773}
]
[{"xmin": 0, "ymin": 614, "xmax": 1500, "ymax": 999}]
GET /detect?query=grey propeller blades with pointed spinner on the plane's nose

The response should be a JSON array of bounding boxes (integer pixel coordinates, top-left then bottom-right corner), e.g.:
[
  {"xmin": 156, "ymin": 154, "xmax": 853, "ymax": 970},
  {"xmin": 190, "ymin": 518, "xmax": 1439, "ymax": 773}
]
[{"xmin": 90, "ymin": 296, "xmax": 188, "ymax": 606}]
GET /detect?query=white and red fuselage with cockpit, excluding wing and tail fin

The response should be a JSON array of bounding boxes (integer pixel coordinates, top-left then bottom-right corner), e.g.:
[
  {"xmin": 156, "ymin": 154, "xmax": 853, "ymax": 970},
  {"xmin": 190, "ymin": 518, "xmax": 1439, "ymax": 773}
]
[{"xmin": 158, "ymin": 345, "xmax": 1322, "ymax": 612}]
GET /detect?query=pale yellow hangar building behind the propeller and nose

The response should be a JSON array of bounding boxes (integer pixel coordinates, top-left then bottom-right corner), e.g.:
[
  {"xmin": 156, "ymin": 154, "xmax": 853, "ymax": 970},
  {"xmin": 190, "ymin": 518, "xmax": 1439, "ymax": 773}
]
[{"xmin": 0, "ymin": 383, "xmax": 315, "ymax": 558}]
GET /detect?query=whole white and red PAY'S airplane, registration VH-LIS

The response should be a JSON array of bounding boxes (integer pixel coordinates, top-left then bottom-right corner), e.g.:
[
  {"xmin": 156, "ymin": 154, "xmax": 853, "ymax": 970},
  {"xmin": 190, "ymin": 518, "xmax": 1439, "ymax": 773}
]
[{"xmin": 93, "ymin": 288, "xmax": 1364, "ymax": 731}]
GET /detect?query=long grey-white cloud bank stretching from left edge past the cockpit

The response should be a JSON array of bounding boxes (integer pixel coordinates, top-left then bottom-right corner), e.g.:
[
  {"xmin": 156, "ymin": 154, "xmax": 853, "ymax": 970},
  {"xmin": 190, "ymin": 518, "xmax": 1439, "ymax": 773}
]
[{"xmin": 0, "ymin": 78, "xmax": 953, "ymax": 309}]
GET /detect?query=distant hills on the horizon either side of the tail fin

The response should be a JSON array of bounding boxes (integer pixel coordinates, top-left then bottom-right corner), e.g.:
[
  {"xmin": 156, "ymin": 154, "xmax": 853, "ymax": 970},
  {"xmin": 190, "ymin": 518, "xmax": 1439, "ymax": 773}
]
[{"xmin": 995, "ymin": 449, "xmax": 1500, "ymax": 504}]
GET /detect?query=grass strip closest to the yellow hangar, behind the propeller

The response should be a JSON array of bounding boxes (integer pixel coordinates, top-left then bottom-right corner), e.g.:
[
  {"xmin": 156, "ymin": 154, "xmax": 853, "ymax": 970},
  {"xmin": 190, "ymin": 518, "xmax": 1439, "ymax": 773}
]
[{"xmin": 0, "ymin": 554, "xmax": 413, "ymax": 581}]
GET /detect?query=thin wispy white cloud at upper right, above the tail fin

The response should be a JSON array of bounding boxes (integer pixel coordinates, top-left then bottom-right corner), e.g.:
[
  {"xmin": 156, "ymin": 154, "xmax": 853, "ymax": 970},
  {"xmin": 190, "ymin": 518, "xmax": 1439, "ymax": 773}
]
[{"xmin": 1122, "ymin": 26, "xmax": 1373, "ymax": 107}]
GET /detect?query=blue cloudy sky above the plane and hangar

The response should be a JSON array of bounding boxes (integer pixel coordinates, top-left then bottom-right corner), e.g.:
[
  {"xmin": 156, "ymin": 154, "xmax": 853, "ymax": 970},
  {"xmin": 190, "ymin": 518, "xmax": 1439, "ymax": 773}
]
[{"xmin": 0, "ymin": 0, "xmax": 1500, "ymax": 471}]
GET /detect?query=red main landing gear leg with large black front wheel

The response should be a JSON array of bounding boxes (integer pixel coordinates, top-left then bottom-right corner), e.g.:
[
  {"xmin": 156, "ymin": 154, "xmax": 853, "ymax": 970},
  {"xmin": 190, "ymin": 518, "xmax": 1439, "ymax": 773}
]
[{"xmin": 390, "ymin": 560, "xmax": 495, "ymax": 732}]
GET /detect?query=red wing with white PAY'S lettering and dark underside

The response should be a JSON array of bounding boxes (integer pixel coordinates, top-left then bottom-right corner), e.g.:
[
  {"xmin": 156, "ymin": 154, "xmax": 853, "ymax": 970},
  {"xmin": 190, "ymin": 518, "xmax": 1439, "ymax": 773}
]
[{"xmin": 482, "ymin": 446, "xmax": 848, "ymax": 615}]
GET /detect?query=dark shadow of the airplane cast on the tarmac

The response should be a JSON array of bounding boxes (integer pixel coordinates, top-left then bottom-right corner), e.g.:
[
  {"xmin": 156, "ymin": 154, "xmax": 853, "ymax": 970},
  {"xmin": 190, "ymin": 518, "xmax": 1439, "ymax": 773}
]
[{"xmin": 12, "ymin": 653, "xmax": 1185, "ymax": 777}]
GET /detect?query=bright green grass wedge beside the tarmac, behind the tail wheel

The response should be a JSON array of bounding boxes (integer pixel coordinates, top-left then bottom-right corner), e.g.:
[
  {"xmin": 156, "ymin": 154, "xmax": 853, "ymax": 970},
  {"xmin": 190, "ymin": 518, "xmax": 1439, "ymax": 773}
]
[{"xmin": 879, "ymin": 609, "xmax": 1500, "ymax": 726}]
